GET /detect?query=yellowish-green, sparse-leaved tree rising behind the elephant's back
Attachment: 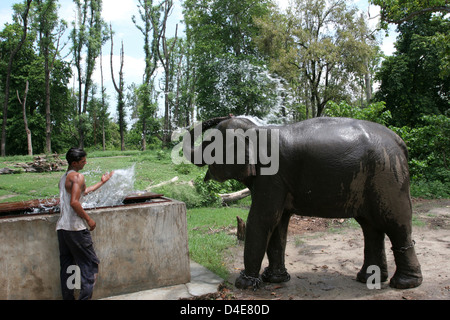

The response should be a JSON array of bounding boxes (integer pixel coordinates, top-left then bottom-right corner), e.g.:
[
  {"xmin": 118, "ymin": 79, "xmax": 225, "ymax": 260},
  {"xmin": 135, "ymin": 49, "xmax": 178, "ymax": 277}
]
[{"xmin": 258, "ymin": 0, "xmax": 376, "ymax": 118}]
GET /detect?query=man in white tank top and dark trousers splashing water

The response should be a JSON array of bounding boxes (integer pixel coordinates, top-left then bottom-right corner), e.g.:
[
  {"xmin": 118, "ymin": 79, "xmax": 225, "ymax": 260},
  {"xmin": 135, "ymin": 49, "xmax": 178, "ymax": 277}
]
[{"xmin": 56, "ymin": 148, "xmax": 113, "ymax": 300}]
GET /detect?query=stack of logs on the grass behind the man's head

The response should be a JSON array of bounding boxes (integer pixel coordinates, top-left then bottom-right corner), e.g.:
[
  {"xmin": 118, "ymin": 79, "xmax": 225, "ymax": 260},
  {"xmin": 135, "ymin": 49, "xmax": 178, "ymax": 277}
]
[{"xmin": 0, "ymin": 154, "xmax": 67, "ymax": 174}]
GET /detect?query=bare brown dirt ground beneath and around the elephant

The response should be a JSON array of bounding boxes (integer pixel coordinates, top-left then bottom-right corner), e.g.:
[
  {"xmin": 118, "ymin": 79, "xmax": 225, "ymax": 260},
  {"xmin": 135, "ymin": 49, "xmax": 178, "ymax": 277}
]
[{"xmin": 219, "ymin": 200, "xmax": 450, "ymax": 300}]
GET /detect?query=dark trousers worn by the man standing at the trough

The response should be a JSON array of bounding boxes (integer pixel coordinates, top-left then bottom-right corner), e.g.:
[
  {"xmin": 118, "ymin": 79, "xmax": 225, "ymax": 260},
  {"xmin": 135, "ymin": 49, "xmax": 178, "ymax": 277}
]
[{"xmin": 57, "ymin": 230, "xmax": 100, "ymax": 300}]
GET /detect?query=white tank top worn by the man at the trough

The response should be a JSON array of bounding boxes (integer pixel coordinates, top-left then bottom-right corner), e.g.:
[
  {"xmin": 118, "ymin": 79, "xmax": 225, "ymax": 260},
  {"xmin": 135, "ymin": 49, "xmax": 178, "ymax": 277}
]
[{"xmin": 56, "ymin": 170, "xmax": 87, "ymax": 231}]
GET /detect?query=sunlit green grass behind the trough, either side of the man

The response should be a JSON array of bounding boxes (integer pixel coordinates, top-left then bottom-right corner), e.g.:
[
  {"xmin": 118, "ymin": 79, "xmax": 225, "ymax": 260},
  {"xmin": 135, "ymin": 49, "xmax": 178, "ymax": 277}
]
[{"xmin": 0, "ymin": 151, "xmax": 204, "ymax": 202}]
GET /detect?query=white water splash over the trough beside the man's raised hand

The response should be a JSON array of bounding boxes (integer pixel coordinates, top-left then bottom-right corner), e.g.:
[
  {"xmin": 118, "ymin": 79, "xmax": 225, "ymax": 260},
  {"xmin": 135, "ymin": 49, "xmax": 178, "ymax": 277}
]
[{"xmin": 82, "ymin": 165, "xmax": 136, "ymax": 209}]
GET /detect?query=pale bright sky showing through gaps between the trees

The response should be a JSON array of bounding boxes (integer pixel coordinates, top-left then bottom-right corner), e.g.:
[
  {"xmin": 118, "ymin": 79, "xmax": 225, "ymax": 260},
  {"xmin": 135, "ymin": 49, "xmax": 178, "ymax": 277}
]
[{"xmin": 0, "ymin": 0, "xmax": 396, "ymax": 119}]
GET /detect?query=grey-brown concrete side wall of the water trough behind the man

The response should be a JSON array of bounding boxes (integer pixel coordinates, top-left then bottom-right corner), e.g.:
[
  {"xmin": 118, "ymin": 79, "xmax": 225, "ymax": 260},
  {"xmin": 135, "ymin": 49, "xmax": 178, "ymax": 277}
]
[{"xmin": 0, "ymin": 200, "xmax": 190, "ymax": 299}]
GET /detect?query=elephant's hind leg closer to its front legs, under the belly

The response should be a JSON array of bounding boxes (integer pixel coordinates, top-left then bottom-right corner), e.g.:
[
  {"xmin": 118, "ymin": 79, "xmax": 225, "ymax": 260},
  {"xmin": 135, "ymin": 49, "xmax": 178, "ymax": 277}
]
[{"xmin": 356, "ymin": 218, "xmax": 388, "ymax": 283}]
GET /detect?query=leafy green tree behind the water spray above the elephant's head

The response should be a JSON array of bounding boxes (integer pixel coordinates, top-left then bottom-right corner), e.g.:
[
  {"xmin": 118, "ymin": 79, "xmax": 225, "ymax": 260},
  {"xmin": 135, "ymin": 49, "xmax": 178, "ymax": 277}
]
[{"xmin": 184, "ymin": 0, "xmax": 272, "ymax": 118}]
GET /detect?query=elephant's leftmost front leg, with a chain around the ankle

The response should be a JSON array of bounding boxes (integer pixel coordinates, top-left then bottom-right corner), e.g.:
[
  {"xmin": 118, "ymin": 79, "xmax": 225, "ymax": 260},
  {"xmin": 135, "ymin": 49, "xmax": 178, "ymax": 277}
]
[{"xmin": 235, "ymin": 185, "xmax": 285, "ymax": 289}]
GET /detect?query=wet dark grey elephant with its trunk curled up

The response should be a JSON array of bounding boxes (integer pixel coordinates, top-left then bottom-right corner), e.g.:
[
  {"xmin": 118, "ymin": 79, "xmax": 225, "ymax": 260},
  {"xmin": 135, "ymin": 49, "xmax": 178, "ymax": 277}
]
[{"xmin": 183, "ymin": 115, "xmax": 423, "ymax": 290}]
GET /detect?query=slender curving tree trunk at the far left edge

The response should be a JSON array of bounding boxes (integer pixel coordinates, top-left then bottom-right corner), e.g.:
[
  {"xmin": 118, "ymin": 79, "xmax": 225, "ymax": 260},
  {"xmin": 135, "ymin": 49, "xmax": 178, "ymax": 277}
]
[{"xmin": 1, "ymin": 0, "xmax": 32, "ymax": 157}]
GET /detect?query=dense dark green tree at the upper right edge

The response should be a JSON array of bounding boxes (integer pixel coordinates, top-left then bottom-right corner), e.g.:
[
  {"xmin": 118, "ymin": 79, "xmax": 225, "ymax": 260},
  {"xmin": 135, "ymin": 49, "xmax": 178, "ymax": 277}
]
[{"xmin": 376, "ymin": 13, "xmax": 450, "ymax": 127}]
